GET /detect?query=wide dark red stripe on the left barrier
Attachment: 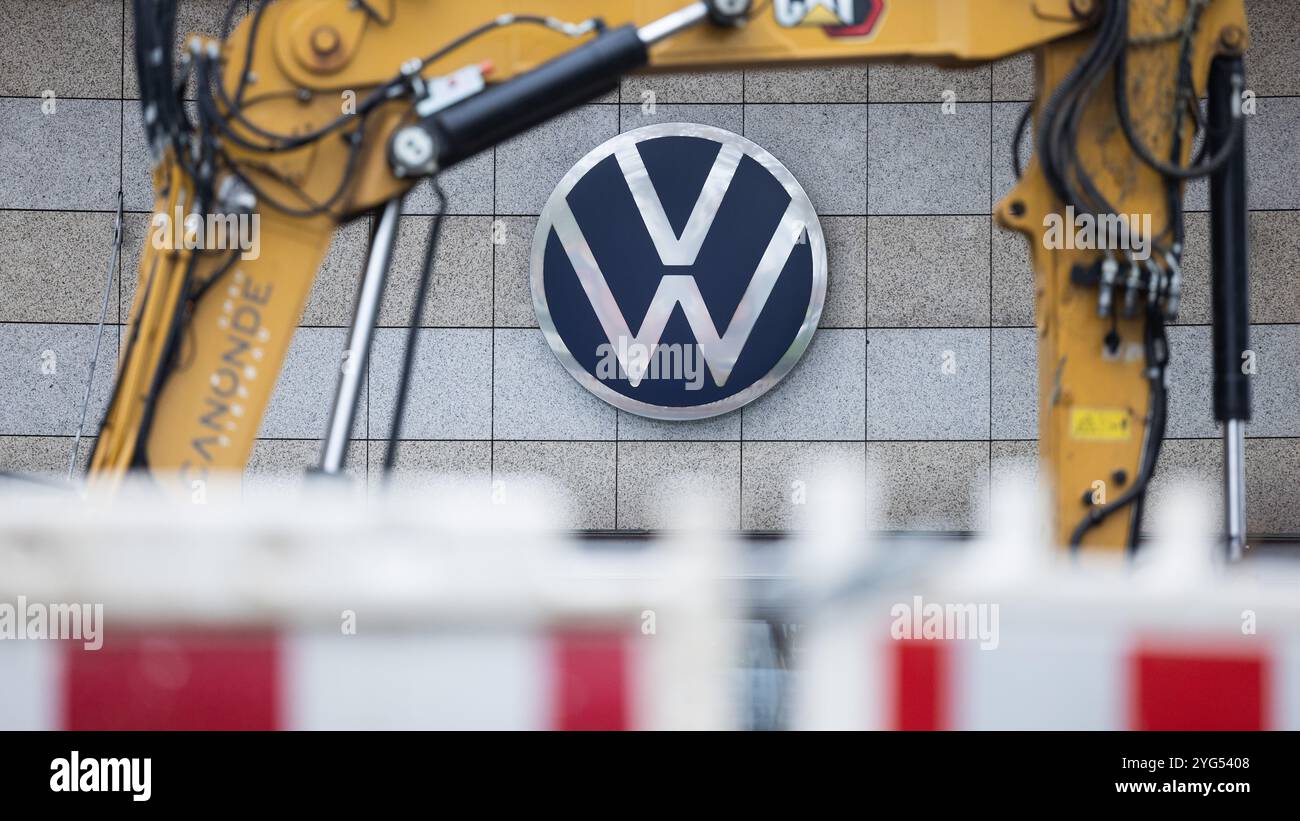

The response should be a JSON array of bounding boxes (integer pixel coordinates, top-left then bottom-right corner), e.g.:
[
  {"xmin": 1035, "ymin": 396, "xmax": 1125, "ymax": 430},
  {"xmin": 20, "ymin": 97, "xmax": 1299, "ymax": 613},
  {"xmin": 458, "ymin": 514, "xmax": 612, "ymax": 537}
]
[{"xmin": 64, "ymin": 630, "xmax": 280, "ymax": 730}]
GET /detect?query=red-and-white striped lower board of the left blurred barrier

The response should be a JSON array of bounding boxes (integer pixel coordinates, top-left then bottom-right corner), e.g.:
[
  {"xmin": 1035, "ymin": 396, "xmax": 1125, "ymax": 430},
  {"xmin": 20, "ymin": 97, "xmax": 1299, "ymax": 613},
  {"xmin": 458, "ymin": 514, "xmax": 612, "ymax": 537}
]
[{"xmin": 0, "ymin": 627, "xmax": 657, "ymax": 730}]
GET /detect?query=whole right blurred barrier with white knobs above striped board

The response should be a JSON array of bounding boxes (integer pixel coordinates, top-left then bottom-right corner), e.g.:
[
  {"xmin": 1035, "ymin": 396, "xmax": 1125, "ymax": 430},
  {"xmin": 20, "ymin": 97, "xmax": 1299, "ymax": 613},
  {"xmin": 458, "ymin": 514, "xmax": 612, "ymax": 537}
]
[{"xmin": 797, "ymin": 478, "xmax": 1300, "ymax": 730}]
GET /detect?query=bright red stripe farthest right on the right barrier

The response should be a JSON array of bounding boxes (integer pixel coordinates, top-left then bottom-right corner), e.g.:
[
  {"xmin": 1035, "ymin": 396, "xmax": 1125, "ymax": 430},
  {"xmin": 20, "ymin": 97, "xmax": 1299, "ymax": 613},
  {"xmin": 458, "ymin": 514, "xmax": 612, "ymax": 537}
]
[{"xmin": 1128, "ymin": 647, "xmax": 1269, "ymax": 730}]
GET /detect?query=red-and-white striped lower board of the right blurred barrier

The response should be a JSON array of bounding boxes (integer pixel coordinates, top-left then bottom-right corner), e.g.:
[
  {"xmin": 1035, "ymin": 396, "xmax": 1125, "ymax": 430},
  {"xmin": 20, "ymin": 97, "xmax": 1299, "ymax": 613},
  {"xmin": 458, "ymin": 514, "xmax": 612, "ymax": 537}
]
[{"xmin": 803, "ymin": 607, "xmax": 1300, "ymax": 730}]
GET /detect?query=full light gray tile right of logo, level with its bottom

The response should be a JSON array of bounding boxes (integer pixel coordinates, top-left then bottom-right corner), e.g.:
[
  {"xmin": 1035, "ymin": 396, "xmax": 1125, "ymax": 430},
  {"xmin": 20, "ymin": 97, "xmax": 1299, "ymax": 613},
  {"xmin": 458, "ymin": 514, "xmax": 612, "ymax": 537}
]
[{"xmin": 867, "ymin": 329, "xmax": 989, "ymax": 439}]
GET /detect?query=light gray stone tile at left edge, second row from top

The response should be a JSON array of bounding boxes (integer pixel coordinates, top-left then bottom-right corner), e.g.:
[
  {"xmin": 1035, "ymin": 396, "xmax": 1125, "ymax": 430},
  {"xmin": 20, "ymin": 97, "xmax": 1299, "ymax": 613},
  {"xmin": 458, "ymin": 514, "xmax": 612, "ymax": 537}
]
[{"xmin": 0, "ymin": 97, "xmax": 122, "ymax": 210}]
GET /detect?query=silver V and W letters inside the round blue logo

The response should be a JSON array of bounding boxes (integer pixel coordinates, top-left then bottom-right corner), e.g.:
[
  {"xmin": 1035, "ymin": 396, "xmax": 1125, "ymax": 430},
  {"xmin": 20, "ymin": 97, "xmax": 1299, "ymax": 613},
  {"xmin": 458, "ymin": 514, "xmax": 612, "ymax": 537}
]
[{"xmin": 554, "ymin": 145, "xmax": 805, "ymax": 387}]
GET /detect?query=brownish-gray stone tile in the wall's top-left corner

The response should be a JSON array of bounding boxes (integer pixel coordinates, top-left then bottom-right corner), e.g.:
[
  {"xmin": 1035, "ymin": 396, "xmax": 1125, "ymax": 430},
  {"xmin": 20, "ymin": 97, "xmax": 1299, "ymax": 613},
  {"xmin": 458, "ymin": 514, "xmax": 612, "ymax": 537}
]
[{"xmin": 0, "ymin": 0, "xmax": 122, "ymax": 97}]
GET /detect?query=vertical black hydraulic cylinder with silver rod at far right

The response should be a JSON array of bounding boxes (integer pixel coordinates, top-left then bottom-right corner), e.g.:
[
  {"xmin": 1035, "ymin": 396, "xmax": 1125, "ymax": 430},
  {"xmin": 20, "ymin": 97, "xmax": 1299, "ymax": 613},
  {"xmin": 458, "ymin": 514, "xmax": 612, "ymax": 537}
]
[{"xmin": 1205, "ymin": 56, "xmax": 1253, "ymax": 560}]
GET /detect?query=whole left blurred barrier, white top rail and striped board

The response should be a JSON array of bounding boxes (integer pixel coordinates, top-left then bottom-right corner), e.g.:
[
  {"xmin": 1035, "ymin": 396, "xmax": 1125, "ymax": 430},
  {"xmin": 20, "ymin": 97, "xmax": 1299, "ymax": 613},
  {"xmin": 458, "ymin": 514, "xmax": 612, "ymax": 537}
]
[{"xmin": 0, "ymin": 480, "xmax": 736, "ymax": 729}]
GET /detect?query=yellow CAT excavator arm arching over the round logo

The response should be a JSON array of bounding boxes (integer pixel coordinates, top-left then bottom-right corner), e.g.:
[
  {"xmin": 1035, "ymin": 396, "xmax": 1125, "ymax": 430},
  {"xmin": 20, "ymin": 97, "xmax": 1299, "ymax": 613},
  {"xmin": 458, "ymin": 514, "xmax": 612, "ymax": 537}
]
[{"xmin": 90, "ymin": 0, "xmax": 1247, "ymax": 547}]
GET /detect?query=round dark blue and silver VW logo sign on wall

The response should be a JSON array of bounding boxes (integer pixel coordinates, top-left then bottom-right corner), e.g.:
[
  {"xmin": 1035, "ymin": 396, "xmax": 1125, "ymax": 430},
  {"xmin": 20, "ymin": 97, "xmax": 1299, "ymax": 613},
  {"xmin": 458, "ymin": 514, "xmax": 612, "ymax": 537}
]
[{"xmin": 530, "ymin": 123, "xmax": 826, "ymax": 420}]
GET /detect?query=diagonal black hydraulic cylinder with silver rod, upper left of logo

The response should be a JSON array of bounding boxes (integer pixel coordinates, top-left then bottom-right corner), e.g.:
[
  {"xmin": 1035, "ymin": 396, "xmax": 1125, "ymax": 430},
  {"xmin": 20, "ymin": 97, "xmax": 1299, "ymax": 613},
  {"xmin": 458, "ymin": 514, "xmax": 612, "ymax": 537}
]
[{"xmin": 390, "ymin": 3, "xmax": 718, "ymax": 177}]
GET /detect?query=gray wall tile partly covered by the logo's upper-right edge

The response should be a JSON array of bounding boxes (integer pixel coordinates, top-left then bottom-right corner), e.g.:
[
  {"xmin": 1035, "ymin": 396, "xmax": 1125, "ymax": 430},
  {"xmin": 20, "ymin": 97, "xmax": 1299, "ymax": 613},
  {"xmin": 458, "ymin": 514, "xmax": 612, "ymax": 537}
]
[{"xmin": 745, "ymin": 105, "xmax": 874, "ymax": 216}]
